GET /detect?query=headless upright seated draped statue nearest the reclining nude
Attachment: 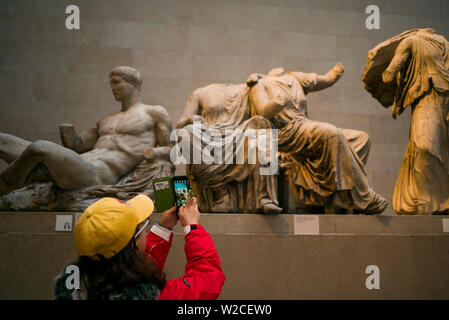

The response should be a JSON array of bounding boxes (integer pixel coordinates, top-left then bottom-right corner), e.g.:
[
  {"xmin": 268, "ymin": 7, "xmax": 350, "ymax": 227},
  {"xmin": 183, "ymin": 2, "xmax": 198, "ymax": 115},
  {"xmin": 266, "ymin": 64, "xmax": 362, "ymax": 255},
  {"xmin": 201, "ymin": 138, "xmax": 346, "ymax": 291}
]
[{"xmin": 176, "ymin": 84, "xmax": 282, "ymax": 213}]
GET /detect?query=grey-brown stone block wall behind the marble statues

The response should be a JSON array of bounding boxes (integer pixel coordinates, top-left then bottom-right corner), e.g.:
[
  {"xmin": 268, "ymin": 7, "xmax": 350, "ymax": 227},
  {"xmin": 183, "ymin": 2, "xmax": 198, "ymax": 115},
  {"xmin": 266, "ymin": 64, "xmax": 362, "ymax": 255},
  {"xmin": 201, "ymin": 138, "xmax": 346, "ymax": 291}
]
[{"xmin": 0, "ymin": 0, "xmax": 449, "ymax": 213}]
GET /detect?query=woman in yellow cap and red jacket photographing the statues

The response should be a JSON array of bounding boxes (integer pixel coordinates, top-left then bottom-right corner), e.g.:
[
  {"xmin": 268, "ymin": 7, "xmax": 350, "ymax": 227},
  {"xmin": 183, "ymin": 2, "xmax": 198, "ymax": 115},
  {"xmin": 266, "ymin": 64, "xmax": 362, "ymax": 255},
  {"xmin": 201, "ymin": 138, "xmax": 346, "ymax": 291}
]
[{"xmin": 53, "ymin": 195, "xmax": 225, "ymax": 300}]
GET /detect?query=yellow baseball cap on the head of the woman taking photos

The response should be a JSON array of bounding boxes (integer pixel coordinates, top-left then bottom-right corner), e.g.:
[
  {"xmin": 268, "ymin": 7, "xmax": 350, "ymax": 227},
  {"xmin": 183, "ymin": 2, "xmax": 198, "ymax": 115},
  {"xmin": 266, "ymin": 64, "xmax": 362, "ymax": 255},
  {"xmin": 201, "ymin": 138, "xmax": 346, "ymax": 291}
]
[{"xmin": 75, "ymin": 195, "xmax": 154, "ymax": 260}]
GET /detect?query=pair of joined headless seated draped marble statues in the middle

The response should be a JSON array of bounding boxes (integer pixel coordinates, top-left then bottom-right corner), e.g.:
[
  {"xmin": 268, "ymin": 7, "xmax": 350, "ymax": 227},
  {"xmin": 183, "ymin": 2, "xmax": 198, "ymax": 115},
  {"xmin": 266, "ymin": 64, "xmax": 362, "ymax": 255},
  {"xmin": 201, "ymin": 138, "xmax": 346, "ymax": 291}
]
[{"xmin": 177, "ymin": 64, "xmax": 387, "ymax": 214}]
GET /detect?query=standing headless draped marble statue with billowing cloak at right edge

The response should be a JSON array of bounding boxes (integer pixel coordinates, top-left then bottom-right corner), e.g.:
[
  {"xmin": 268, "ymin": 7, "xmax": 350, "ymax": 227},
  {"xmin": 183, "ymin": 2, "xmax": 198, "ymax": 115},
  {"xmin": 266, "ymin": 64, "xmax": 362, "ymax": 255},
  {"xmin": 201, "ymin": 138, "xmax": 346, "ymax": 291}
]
[{"xmin": 362, "ymin": 29, "xmax": 449, "ymax": 215}]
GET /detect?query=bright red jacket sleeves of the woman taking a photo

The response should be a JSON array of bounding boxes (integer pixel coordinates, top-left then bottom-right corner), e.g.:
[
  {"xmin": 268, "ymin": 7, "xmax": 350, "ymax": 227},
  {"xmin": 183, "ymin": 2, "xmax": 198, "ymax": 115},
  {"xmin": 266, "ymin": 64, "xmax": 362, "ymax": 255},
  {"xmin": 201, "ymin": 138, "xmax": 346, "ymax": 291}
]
[{"xmin": 145, "ymin": 225, "xmax": 225, "ymax": 300}]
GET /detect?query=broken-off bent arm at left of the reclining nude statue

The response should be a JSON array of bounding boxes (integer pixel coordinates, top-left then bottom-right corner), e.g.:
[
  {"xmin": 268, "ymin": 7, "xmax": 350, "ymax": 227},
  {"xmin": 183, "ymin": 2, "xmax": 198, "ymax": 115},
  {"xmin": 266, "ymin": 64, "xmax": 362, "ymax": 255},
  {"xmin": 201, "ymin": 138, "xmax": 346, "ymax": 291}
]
[{"xmin": 59, "ymin": 123, "xmax": 98, "ymax": 153}]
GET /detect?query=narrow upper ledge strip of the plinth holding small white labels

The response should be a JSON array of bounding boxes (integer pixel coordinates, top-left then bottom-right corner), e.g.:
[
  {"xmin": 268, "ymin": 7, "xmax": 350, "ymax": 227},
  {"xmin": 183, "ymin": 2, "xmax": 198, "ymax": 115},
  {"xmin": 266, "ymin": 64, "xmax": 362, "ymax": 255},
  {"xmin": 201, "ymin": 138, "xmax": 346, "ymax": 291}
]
[{"xmin": 0, "ymin": 211, "xmax": 449, "ymax": 235}]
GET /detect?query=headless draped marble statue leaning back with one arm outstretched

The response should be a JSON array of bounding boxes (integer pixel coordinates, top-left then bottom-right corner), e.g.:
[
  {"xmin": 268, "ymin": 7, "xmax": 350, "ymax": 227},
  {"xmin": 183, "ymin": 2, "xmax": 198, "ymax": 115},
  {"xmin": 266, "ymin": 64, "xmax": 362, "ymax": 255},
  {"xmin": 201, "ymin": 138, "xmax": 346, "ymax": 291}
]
[{"xmin": 247, "ymin": 64, "xmax": 387, "ymax": 214}]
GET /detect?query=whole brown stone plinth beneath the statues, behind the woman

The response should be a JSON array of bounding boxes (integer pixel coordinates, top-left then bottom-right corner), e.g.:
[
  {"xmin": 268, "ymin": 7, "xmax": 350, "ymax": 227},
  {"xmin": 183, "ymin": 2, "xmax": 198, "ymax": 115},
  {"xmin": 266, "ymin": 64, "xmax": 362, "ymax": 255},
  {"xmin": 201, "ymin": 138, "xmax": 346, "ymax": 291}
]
[{"xmin": 0, "ymin": 212, "xmax": 449, "ymax": 299}]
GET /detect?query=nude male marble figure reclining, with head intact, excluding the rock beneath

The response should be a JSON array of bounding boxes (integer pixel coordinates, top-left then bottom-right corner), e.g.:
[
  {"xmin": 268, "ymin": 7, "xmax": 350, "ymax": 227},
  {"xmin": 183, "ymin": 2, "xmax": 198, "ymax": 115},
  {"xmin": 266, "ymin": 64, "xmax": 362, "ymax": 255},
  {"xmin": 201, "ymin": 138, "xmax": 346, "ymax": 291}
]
[{"xmin": 0, "ymin": 67, "xmax": 171, "ymax": 195}]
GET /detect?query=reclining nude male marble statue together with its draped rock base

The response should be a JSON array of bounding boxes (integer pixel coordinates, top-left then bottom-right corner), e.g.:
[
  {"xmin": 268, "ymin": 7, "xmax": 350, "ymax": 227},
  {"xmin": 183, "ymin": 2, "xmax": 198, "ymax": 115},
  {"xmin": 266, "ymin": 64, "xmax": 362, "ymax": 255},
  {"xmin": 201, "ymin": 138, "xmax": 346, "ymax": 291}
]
[{"xmin": 0, "ymin": 66, "xmax": 174, "ymax": 210}]
